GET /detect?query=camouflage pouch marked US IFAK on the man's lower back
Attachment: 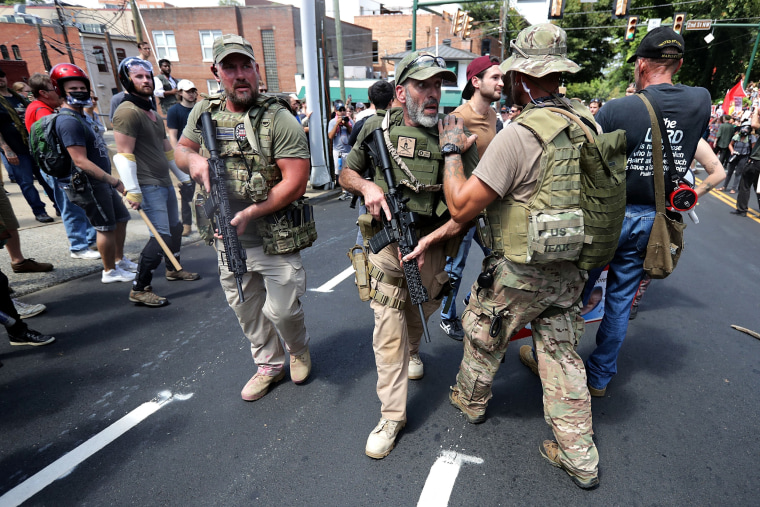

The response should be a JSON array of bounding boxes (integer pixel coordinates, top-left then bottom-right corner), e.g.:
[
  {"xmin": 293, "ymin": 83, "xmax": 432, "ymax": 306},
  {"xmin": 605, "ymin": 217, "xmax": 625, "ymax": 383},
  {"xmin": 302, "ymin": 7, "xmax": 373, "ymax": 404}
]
[{"xmin": 526, "ymin": 209, "xmax": 585, "ymax": 264}]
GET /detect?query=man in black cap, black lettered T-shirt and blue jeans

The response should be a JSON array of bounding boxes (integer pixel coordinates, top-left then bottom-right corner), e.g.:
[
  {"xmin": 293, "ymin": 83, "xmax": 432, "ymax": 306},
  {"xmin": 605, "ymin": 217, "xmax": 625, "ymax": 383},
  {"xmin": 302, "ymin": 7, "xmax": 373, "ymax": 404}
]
[{"xmin": 568, "ymin": 27, "xmax": 724, "ymax": 412}]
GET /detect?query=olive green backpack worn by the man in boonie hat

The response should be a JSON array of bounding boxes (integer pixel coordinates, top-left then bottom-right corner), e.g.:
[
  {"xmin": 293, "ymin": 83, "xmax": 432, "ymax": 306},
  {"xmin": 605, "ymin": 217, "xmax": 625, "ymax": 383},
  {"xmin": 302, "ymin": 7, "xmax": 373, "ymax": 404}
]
[{"xmin": 547, "ymin": 107, "xmax": 627, "ymax": 270}]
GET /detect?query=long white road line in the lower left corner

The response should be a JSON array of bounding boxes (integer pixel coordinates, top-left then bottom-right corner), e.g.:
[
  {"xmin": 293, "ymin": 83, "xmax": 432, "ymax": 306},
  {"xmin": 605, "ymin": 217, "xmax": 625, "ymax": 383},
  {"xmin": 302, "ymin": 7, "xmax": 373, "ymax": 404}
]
[{"xmin": 0, "ymin": 391, "xmax": 192, "ymax": 506}]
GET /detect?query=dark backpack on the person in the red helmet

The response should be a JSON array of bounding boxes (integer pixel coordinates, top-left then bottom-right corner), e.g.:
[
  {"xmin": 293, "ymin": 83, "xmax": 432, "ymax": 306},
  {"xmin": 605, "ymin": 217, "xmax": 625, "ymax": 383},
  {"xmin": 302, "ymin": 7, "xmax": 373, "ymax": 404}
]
[{"xmin": 29, "ymin": 109, "xmax": 84, "ymax": 178}]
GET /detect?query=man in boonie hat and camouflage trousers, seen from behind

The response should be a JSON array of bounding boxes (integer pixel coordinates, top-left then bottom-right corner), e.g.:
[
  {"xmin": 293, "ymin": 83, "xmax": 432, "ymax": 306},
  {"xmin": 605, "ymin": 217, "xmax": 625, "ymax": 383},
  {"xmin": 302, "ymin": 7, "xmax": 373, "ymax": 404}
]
[{"xmin": 439, "ymin": 24, "xmax": 599, "ymax": 488}]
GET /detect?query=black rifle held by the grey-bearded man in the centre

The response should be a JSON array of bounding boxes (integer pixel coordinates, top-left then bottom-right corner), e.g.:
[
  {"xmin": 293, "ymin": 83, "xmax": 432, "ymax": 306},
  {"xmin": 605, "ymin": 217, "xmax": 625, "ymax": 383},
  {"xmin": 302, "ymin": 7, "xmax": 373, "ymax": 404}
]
[{"xmin": 364, "ymin": 128, "xmax": 430, "ymax": 343}]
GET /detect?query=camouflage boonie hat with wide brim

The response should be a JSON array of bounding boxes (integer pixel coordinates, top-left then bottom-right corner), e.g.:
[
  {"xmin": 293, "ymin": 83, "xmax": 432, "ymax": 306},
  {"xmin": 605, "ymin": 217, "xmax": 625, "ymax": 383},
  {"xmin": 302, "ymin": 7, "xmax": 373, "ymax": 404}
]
[{"xmin": 499, "ymin": 23, "xmax": 581, "ymax": 77}]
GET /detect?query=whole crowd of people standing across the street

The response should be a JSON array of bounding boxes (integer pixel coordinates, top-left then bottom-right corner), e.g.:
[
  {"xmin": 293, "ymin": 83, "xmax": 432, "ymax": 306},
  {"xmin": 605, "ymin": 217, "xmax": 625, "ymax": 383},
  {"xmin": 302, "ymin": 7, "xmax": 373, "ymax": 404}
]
[{"xmin": 0, "ymin": 23, "xmax": 760, "ymax": 489}]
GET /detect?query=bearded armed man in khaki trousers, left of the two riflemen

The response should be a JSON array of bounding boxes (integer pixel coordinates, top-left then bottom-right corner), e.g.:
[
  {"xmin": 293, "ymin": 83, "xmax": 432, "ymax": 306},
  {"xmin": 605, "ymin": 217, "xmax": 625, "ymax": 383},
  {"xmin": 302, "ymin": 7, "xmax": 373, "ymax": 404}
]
[{"xmin": 177, "ymin": 35, "xmax": 316, "ymax": 401}]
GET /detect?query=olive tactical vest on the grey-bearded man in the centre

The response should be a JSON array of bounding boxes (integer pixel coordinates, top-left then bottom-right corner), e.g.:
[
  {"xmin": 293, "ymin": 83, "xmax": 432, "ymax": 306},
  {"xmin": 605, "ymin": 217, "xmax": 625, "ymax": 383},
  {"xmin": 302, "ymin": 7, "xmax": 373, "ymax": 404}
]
[{"xmin": 374, "ymin": 108, "xmax": 447, "ymax": 219}]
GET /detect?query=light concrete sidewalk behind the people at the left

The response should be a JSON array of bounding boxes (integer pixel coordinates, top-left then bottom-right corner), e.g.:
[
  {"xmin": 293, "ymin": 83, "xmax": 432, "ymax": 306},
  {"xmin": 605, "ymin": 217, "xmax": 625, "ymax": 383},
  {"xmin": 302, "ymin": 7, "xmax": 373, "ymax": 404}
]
[{"xmin": 0, "ymin": 139, "xmax": 340, "ymax": 297}]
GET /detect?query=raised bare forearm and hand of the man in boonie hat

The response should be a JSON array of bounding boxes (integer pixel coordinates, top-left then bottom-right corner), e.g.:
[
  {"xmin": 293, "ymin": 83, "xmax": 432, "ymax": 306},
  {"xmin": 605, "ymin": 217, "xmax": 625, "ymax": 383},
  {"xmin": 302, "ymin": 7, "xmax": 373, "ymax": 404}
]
[{"xmin": 438, "ymin": 115, "xmax": 498, "ymax": 224}]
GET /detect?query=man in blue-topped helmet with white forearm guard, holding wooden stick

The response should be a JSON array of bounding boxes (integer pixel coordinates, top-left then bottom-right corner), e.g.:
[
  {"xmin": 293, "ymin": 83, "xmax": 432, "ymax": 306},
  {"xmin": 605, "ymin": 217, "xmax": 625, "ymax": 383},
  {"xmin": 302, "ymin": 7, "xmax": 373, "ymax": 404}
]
[{"xmin": 113, "ymin": 57, "xmax": 200, "ymax": 307}]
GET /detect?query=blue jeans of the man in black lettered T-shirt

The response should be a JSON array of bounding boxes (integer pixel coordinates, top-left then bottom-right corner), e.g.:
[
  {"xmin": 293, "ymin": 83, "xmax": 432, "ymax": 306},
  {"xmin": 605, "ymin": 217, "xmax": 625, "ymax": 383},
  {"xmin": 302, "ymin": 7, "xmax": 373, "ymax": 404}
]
[{"xmin": 584, "ymin": 204, "xmax": 655, "ymax": 389}]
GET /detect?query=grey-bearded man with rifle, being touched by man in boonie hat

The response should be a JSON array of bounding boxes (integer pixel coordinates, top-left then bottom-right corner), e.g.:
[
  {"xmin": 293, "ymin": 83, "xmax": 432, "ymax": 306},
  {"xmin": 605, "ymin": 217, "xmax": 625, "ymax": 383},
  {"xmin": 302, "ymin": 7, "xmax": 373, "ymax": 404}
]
[{"xmin": 340, "ymin": 52, "xmax": 478, "ymax": 459}]
